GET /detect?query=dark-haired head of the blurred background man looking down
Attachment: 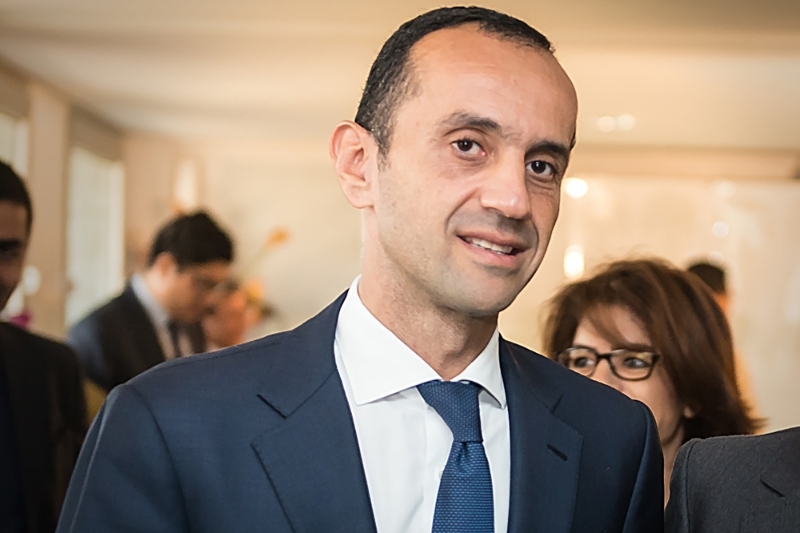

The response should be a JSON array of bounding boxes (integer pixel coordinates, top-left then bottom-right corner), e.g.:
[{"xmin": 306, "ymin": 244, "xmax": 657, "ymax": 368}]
[{"xmin": 142, "ymin": 211, "xmax": 233, "ymax": 323}]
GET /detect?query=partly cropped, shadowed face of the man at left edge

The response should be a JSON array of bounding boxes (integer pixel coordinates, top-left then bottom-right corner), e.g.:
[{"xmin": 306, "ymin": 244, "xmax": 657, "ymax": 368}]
[{"xmin": 0, "ymin": 201, "xmax": 28, "ymax": 309}]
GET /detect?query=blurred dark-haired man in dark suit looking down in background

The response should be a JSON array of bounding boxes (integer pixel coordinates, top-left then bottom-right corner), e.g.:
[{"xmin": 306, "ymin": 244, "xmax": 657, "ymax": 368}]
[{"xmin": 68, "ymin": 212, "xmax": 233, "ymax": 391}]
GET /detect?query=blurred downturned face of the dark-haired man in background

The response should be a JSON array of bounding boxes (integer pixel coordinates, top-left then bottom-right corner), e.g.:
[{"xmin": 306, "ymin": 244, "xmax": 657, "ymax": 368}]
[{"xmin": 159, "ymin": 261, "xmax": 230, "ymax": 323}]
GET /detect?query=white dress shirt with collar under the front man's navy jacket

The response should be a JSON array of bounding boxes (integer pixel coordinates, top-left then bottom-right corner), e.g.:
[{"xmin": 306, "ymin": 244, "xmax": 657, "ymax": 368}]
[{"xmin": 334, "ymin": 277, "xmax": 511, "ymax": 533}]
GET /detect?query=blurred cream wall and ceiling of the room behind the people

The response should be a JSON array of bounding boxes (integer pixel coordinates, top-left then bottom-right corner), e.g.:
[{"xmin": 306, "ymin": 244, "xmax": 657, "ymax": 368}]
[{"xmin": 0, "ymin": 0, "xmax": 800, "ymax": 430}]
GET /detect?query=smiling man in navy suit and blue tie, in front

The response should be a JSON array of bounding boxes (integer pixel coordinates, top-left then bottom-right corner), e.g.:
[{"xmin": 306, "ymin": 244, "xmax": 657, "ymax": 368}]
[{"xmin": 59, "ymin": 7, "xmax": 663, "ymax": 533}]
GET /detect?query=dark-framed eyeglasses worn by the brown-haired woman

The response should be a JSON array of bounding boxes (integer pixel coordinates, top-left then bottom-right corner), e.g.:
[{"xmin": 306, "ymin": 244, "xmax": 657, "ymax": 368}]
[{"xmin": 556, "ymin": 346, "xmax": 659, "ymax": 381}]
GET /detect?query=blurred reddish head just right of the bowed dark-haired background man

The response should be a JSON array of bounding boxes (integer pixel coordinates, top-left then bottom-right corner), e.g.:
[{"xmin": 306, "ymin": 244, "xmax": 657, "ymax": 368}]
[{"xmin": 203, "ymin": 281, "xmax": 250, "ymax": 349}]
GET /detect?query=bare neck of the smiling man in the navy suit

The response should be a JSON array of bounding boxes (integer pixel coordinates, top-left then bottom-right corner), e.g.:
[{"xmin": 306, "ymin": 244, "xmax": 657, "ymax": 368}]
[{"xmin": 358, "ymin": 275, "xmax": 497, "ymax": 380}]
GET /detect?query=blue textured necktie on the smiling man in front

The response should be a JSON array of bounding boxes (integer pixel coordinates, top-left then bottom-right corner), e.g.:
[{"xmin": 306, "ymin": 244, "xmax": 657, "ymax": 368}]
[{"xmin": 417, "ymin": 381, "xmax": 494, "ymax": 533}]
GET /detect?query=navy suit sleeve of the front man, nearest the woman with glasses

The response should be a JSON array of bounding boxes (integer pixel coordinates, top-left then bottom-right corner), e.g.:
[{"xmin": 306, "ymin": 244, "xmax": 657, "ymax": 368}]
[{"xmin": 622, "ymin": 402, "xmax": 664, "ymax": 533}]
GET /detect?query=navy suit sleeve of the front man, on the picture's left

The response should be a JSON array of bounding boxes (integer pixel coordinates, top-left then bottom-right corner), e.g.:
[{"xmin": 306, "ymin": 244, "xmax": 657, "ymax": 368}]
[{"xmin": 57, "ymin": 385, "xmax": 189, "ymax": 533}]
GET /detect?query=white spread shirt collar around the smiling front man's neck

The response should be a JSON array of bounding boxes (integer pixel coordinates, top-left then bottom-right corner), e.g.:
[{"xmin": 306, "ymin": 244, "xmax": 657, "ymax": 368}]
[{"xmin": 336, "ymin": 276, "xmax": 506, "ymax": 409}]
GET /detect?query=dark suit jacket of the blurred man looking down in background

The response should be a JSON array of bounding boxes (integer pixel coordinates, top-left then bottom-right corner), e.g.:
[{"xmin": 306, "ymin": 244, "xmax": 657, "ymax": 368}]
[{"xmin": 67, "ymin": 284, "xmax": 206, "ymax": 391}]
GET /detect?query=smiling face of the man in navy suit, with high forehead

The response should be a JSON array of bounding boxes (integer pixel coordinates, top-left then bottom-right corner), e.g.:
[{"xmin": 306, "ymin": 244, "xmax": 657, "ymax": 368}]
[{"xmin": 365, "ymin": 26, "xmax": 577, "ymax": 316}]
